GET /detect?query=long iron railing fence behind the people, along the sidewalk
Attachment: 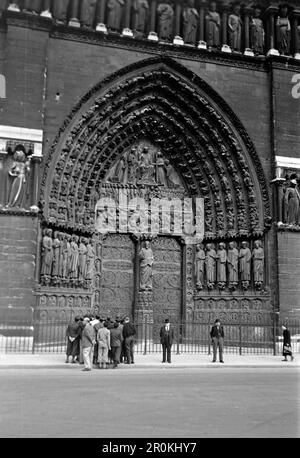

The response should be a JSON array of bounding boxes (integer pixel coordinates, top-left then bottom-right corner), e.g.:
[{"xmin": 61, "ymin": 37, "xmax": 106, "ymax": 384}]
[{"xmin": 0, "ymin": 319, "xmax": 300, "ymax": 355}]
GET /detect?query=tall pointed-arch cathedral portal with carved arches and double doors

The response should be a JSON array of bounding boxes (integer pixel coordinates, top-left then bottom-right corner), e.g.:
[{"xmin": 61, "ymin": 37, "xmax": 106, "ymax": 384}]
[{"xmin": 37, "ymin": 57, "xmax": 271, "ymax": 330}]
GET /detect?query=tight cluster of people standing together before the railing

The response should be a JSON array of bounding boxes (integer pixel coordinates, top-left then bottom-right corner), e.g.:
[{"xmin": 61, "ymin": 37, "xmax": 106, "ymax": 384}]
[{"xmin": 66, "ymin": 315, "xmax": 136, "ymax": 371}]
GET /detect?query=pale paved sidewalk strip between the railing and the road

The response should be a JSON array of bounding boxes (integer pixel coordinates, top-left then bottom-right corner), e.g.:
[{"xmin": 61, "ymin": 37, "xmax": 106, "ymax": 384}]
[{"xmin": 0, "ymin": 353, "xmax": 300, "ymax": 370}]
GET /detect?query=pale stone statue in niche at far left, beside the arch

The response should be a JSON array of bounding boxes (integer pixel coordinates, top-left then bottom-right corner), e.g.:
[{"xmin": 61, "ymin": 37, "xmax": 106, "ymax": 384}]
[{"xmin": 6, "ymin": 146, "xmax": 30, "ymax": 207}]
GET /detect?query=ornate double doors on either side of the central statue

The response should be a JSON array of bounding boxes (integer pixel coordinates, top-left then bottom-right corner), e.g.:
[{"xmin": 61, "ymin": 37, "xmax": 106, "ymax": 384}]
[{"xmin": 94, "ymin": 234, "xmax": 182, "ymax": 323}]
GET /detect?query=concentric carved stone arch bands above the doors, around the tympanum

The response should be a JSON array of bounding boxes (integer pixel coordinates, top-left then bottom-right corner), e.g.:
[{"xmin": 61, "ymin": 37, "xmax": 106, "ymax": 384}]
[{"xmin": 40, "ymin": 57, "xmax": 271, "ymax": 240}]
